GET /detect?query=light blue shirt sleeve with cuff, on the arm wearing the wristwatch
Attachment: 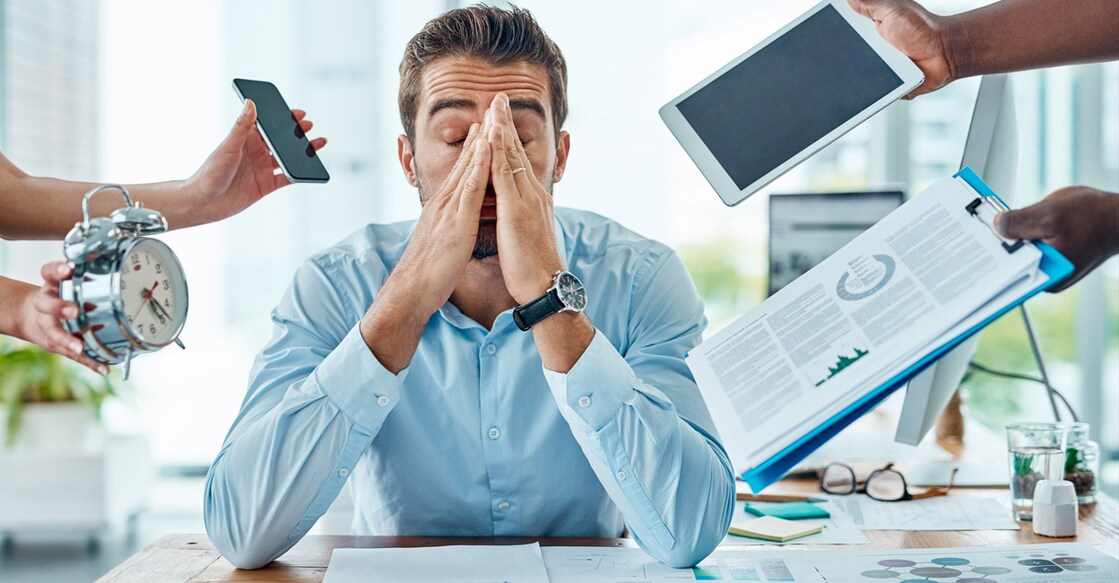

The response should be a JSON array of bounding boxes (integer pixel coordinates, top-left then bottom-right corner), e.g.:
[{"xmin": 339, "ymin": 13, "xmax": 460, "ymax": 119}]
[{"xmin": 544, "ymin": 251, "xmax": 735, "ymax": 567}]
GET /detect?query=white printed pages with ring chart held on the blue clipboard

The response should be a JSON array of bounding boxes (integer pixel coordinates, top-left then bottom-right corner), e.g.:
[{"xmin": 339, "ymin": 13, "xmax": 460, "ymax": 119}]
[{"xmin": 687, "ymin": 178, "xmax": 1041, "ymax": 473}]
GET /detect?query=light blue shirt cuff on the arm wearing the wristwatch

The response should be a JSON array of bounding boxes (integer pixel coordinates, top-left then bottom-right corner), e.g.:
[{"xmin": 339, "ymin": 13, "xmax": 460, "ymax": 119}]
[{"xmin": 544, "ymin": 330, "xmax": 638, "ymax": 432}]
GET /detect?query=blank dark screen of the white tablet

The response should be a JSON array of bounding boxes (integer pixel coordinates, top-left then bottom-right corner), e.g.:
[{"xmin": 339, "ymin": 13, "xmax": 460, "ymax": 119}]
[{"xmin": 677, "ymin": 6, "xmax": 902, "ymax": 190}]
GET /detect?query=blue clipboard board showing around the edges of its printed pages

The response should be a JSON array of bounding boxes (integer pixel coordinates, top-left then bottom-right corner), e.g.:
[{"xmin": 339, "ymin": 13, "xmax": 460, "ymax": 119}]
[{"xmin": 742, "ymin": 167, "xmax": 1073, "ymax": 492}]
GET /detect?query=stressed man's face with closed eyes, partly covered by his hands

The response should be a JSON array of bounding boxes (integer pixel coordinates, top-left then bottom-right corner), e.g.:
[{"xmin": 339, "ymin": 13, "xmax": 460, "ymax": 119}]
[{"xmin": 397, "ymin": 57, "xmax": 570, "ymax": 260}]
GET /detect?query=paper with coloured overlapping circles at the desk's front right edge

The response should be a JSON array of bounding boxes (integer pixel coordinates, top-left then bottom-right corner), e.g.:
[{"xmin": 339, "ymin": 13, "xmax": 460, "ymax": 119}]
[{"xmin": 812, "ymin": 543, "xmax": 1119, "ymax": 583}]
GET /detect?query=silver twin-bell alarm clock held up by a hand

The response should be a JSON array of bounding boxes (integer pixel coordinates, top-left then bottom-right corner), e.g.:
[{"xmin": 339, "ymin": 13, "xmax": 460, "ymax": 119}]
[{"xmin": 58, "ymin": 185, "xmax": 188, "ymax": 378}]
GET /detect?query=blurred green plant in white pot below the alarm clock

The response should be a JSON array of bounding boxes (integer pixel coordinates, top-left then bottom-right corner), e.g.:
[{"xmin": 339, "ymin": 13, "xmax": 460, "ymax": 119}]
[{"xmin": 0, "ymin": 339, "xmax": 116, "ymax": 448}]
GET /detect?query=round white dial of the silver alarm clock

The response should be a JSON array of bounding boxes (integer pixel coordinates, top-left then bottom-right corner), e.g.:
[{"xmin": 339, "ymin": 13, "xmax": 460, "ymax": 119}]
[{"xmin": 120, "ymin": 239, "xmax": 187, "ymax": 346}]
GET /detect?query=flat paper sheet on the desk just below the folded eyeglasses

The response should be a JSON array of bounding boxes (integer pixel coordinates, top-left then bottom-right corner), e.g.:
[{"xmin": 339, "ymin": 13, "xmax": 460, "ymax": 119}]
[{"xmin": 828, "ymin": 495, "xmax": 1018, "ymax": 530}]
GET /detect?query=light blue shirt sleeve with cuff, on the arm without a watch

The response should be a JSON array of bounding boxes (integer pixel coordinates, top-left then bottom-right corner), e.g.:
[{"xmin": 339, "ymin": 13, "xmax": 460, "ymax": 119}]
[{"xmin": 204, "ymin": 257, "xmax": 406, "ymax": 568}]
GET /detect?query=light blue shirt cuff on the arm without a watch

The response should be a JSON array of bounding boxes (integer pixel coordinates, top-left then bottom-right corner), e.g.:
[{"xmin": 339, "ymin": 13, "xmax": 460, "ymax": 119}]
[{"xmin": 312, "ymin": 326, "xmax": 408, "ymax": 434}]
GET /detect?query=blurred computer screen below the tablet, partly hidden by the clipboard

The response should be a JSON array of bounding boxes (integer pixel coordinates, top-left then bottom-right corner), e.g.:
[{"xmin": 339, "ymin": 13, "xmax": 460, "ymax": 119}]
[{"xmin": 769, "ymin": 190, "xmax": 905, "ymax": 295}]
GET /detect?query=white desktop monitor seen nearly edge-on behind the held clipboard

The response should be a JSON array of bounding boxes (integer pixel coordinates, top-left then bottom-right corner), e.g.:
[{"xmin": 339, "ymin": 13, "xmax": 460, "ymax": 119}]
[{"xmin": 894, "ymin": 75, "xmax": 1018, "ymax": 445}]
